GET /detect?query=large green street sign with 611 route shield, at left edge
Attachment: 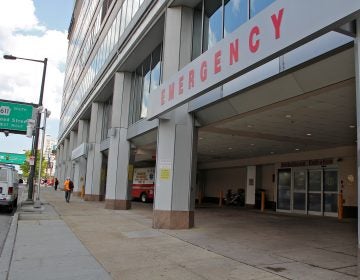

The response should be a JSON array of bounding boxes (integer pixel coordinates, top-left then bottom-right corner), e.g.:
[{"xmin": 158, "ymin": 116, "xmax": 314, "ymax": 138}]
[{"xmin": 0, "ymin": 101, "xmax": 34, "ymax": 134}]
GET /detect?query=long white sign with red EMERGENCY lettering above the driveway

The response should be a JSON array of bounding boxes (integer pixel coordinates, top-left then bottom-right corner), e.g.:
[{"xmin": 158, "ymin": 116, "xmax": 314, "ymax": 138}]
[{"xmin": 148, "ymin": 0, "xmax": 360, "ymax": 120}]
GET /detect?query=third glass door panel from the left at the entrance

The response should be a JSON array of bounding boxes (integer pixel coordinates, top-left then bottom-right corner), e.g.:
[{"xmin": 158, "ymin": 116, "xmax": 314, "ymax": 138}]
[{"xmin": 307, "ymin": 170, "xmax": 323, "ymax": 215}]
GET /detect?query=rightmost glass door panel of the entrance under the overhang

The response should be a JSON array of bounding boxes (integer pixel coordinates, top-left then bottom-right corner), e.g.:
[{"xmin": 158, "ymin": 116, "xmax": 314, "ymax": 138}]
[{"xmin": 323, "ymin": 170, "xmax": 339, "ymax": 216}]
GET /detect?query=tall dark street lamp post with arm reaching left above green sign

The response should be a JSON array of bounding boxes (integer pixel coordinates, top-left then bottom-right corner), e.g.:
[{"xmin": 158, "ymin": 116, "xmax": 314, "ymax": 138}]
[{"xmin": 4, "ymin": 55, "xmax": 48, "ymax": 201}]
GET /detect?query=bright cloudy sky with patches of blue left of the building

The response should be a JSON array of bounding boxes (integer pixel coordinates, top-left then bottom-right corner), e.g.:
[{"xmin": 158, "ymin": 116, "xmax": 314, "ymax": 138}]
[{"xmin": 0, "ymin": 0, "xmax": 74, "ymax": 153}]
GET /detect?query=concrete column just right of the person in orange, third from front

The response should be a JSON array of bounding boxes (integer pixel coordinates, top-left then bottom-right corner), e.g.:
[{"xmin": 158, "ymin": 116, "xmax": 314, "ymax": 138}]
[{"xmin": 84, "ymin": 103, "xmax": 104, "ymax": 201}]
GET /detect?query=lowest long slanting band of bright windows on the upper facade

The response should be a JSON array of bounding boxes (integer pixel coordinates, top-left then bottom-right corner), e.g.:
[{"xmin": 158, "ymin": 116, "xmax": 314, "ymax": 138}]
[{"xmin": 59, "ymin": 0, "xmax": 144, "ymax": 134}]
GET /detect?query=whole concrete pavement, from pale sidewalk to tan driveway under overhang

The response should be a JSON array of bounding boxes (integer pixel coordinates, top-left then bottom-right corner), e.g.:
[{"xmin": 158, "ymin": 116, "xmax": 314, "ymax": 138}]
[{"xmin": 0, "ymin": 188, "xmax": 357, "ymax": 280}]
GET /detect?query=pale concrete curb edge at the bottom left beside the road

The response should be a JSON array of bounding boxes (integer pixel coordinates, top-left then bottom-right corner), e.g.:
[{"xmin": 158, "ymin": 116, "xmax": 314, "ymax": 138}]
[{"xmin": 0, "ymin": 212, "xmax": 19, "ymax": 280}]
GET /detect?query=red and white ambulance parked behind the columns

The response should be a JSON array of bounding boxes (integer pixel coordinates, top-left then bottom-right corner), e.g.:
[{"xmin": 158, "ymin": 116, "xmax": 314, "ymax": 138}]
[{"xmin": 131, "ymin": 167, "xmax": 155, "ymax": 202}]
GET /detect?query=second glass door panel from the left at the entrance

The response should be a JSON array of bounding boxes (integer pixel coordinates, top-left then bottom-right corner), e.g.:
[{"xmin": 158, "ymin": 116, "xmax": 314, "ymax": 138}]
[{"xmin": 292, "ymin": 170, "xmax": 307, "ymax": 213}]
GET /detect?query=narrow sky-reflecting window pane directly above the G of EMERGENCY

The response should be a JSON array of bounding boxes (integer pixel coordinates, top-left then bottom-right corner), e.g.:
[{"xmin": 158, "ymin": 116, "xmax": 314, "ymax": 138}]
[{"xmin": 203, "ymin": 0, "xmax": 223, "ymax": 52}]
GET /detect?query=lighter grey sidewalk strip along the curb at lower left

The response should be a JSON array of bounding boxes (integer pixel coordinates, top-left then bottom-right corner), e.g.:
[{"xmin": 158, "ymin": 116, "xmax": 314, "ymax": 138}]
[{"xmin": 0, "ymin": 188, "xmax": 111, "ymax": 280}]
